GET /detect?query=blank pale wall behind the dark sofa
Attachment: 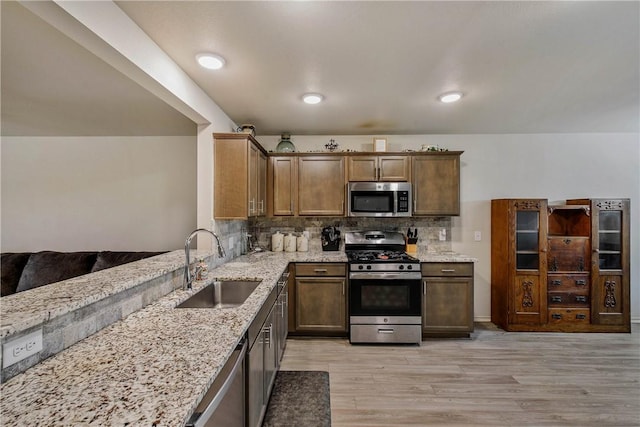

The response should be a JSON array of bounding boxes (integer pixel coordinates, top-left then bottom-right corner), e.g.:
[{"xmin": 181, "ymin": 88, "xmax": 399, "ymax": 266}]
[{"xmin": 0, "ymin": 135, "xmax": 197, "ymax": 252}]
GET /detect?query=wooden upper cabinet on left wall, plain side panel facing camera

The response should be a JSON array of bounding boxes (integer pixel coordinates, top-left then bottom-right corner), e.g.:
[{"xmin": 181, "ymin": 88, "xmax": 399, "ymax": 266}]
[{"xmin": 213, "ymin": 133, "xmax": 267, "ymax": 219}]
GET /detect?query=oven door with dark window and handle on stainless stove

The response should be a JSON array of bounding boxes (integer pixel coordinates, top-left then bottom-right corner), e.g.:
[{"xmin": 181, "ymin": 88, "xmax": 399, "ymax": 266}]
[{"xmin": 349, "ymin": 272, "xmax": 422, "ymax": 317}]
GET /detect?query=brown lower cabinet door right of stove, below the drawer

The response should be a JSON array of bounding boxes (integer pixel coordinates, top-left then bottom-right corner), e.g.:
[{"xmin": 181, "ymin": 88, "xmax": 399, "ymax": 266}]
[{"xmin": 422, "ymin": 277, "xmax": 473, "ymax": 335}]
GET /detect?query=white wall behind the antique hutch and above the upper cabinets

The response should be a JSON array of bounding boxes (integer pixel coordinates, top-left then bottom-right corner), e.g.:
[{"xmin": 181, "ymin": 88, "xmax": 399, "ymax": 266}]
[{"xmin": 258, "ymin": 134, "xmax": 640, "ymax": 322}]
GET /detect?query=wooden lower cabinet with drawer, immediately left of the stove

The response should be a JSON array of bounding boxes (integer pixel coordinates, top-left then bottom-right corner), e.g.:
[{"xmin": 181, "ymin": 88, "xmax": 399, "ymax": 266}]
[{"xmin": 289, "ymin": 263, "xmax": 348, "ymax": 336}]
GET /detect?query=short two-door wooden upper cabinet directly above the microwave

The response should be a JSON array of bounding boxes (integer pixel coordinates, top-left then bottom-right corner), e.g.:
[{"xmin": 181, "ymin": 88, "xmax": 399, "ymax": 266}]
[{"xmin": 347, "ymin": 155, "xmax": 411, "ymax": 181}]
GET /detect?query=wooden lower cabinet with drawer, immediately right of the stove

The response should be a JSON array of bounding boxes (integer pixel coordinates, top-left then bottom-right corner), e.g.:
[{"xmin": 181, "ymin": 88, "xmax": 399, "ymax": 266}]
[{"xmin": 421, "ymin": 262, "xmax": 473, "ymax": 337}]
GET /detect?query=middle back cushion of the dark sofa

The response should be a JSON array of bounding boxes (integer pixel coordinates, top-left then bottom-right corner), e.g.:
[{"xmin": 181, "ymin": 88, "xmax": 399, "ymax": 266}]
[{"xmin": 16, "ymin": 251, "xmax": 97, "ymax": 292}]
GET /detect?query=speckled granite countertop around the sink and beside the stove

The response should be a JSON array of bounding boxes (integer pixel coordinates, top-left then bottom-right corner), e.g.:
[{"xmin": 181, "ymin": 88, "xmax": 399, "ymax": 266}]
[{"xmin": 0, "ymin": 251, "xmax": 475, "ymax": 426}]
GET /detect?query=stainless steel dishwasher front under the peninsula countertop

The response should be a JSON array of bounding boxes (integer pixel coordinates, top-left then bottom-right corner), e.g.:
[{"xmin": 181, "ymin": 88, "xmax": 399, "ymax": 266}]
[{"xmin": 186, "ymin": 338, "xmax": 247, "ymax": 427}]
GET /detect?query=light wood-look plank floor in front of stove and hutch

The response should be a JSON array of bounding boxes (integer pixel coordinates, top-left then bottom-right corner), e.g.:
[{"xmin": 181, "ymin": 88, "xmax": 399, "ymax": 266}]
[{"xmin": 281, "ymin": 323, "xmax": 640, "ymax": 427}]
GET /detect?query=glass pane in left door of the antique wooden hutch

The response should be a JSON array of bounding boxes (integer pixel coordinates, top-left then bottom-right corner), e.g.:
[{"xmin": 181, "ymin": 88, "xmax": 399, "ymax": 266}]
[{"xmin": 516, "ymin": 211, "xmax": 540, "ymax": 270}]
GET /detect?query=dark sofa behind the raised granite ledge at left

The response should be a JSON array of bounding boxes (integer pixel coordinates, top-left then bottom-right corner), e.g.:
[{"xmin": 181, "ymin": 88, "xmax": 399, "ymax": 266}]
[{"xmin": 0, "ymin": 251, "xmax": 165, "ymax": 296}]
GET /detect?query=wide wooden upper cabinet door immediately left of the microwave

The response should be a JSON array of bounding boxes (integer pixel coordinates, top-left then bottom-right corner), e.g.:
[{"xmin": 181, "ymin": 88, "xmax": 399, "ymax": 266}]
[{"xmin": 298, "ymin": 156, "xmax": 345, "ymax": 216}]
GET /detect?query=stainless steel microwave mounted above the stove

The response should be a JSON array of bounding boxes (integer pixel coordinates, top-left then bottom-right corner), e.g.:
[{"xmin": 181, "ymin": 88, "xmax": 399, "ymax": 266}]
[{"xmin": 347, "ymin": 182, "xmax": 413, "ymax": 217}]
